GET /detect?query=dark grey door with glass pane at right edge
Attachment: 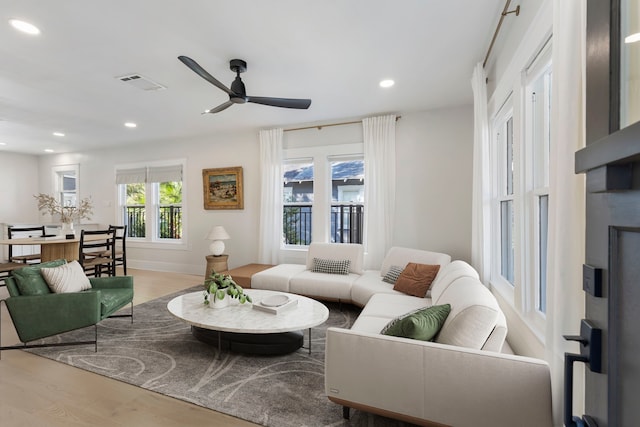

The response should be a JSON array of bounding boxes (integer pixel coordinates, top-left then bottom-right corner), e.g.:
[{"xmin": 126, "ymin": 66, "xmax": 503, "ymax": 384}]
[{"xmin": 565, "ymin": 0, "xmax": 640, "ymax": 427}]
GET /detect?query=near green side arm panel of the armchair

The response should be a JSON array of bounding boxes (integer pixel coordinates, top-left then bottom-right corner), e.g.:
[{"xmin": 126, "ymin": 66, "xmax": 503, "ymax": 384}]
[{"xmin": 5, "ymin": 291, "xmax": 100, "ymax": 343}]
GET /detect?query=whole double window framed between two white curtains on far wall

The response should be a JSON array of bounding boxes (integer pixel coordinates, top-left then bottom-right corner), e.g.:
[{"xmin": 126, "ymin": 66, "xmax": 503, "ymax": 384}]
[{"xmin": 282, "ymin": 144, "xmax": 365, "ymax": 249}]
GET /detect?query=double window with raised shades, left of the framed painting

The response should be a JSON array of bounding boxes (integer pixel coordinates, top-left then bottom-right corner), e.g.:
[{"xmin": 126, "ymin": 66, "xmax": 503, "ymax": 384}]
[{"xmin": 116, "ymin": 164, "xmax": 184, "ymax": 242}]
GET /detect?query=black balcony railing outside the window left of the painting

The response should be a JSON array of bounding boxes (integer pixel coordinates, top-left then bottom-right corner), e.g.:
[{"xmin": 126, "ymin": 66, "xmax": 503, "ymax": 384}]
[{"xmin": 126, "ymin": 205, "xmax": 182, "ymax": 239}]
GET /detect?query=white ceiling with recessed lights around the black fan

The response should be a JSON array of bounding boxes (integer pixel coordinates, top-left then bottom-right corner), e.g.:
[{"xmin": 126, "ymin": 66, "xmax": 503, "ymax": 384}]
[{"xmin": 0, "ymin": 0, "xmax": 504, "ymax": 155}]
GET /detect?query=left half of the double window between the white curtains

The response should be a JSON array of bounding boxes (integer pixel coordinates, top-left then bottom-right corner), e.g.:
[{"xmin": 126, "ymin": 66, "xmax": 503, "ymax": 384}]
[{"xmin": 282, "ymin": 159, "xmax": 313, "ymax": 246}]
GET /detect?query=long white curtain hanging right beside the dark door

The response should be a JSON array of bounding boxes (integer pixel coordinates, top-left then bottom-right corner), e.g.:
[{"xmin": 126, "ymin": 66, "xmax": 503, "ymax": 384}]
[{"xmin": 545, "ymin": 0, "xmax": 586, "ymax": 425}]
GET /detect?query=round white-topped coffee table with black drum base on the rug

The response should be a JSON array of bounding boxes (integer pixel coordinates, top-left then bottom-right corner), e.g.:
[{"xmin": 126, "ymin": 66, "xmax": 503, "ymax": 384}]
[{"xmin": 167, "ymin": 289, "xmax": 329, "ymax": 354}]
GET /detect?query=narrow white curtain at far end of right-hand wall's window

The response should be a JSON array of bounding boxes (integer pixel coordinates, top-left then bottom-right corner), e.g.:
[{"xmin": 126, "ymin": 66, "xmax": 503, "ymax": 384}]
[{"xmin": 471, "ymin": 63, "xmax": 491, "ymax": 284}]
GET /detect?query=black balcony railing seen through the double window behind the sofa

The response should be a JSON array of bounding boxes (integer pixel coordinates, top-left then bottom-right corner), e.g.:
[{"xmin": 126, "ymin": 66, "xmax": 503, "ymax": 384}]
[{"xmin": 282, "ymin": 204, "xmax": 364, "ymax": 246}]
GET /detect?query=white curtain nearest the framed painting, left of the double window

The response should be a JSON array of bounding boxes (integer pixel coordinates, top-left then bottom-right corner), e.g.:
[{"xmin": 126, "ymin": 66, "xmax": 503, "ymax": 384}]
[{"xmin": 258, "ymin": 129, "xmax": 283, "ymax": 265}]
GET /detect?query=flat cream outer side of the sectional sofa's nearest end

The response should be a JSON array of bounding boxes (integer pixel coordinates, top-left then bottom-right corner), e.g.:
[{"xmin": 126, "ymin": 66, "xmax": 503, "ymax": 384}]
[{"xmin": 325, "ymin": 328, "xmax": 552, "ymax": 427}]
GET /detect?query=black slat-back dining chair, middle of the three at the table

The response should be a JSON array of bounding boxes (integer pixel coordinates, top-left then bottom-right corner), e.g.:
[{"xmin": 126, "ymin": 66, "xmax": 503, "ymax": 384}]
[{"xmin": 78, "ymin": 229, "xmax": 116, "ymax": 277}]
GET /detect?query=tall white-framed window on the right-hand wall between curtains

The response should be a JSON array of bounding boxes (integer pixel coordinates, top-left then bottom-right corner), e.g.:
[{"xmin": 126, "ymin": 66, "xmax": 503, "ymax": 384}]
[{"xmin": 491, "ymin": 41, "xmax": 553, "ymax": 336}]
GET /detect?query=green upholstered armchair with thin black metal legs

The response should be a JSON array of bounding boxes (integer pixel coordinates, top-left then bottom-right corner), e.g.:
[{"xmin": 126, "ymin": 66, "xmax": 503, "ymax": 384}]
[{"xmin": 0, "ymin": 260, "xmax": 133, "ymax": 358}]
